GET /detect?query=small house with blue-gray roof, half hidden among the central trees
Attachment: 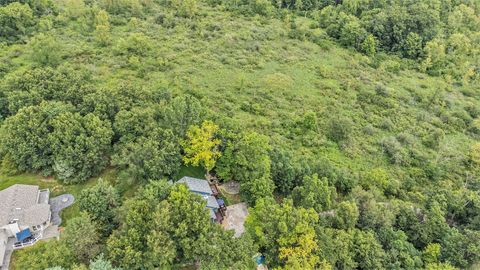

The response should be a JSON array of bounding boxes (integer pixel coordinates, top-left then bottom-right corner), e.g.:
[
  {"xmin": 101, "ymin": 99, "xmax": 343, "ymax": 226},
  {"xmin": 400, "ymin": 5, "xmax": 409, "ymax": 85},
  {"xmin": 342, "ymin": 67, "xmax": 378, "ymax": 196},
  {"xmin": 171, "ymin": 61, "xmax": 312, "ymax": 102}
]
[{"xmin": 177, "ymin": 176, "xmax": 225, "ymax": 223}]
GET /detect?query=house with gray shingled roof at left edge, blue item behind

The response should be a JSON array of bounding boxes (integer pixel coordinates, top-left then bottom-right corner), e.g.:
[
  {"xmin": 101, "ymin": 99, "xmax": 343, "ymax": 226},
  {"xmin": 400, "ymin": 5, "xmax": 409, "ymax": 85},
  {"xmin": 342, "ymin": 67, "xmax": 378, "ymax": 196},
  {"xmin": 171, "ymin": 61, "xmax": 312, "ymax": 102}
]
[{"xmin": 0, "ymin": 184, "xmax": 51, "ymax": 266}]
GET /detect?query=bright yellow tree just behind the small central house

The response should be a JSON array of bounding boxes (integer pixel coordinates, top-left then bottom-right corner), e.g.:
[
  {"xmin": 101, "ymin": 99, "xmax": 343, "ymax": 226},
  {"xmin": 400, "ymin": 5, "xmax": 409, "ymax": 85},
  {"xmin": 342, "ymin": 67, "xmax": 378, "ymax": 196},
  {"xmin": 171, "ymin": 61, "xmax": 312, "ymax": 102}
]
[{"xmin": 182, "ymin": 121, "xmax": 222, "ymax": 174}]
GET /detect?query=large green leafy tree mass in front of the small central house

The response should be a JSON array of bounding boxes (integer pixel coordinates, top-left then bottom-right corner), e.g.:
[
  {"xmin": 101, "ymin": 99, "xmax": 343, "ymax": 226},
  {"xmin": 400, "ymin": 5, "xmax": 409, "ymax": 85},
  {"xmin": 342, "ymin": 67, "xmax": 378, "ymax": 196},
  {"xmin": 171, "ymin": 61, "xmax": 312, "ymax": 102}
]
[{"xmin": 107, "ymin": 181, "xmax": 254, "ymax": 269}]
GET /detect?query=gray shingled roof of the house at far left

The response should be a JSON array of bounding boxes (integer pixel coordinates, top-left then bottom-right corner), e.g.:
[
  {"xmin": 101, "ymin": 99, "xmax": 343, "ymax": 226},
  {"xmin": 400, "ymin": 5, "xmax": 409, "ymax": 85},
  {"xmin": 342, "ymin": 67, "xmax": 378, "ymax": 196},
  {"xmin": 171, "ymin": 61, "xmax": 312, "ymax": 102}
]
[{"xmin": 0, "ymin": 184, "xmax": 50, "ymax": 226}]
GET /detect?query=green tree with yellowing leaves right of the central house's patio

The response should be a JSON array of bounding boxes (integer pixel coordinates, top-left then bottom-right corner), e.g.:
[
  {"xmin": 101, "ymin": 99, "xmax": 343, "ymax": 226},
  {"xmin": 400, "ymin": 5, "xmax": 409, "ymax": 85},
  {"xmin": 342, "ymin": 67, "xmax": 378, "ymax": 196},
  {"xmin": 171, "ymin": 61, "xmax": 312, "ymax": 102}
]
[{"xmin": 245, "ymin": 198, "xmax": 320, "ymax": 269}]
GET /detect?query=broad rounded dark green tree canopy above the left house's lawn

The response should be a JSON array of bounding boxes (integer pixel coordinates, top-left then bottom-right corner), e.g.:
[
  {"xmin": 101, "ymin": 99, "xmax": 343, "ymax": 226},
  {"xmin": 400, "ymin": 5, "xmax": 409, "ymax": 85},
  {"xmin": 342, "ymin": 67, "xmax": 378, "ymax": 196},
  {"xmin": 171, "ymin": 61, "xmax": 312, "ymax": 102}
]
[{"xmin": 1, "ymin": 102, "xmax": 112, "ymax": 183}]
